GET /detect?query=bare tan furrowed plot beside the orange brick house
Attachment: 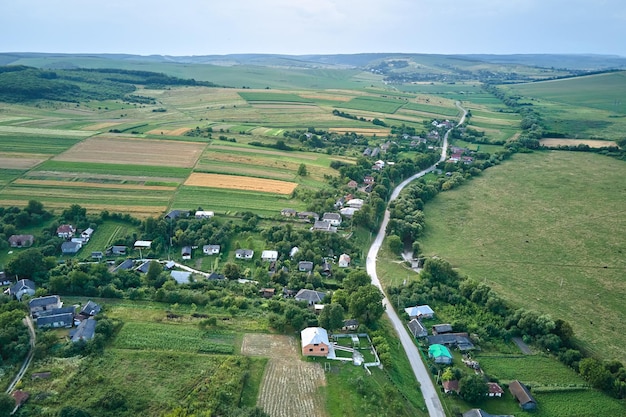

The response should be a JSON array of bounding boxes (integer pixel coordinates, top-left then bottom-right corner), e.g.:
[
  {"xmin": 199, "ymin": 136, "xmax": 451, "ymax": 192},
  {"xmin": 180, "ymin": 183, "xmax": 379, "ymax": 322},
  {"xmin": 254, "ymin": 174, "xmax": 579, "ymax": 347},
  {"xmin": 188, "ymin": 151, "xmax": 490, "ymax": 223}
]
[{"xmin": 241, "ymin": 334, "xmax": 327, "ymax": 417}]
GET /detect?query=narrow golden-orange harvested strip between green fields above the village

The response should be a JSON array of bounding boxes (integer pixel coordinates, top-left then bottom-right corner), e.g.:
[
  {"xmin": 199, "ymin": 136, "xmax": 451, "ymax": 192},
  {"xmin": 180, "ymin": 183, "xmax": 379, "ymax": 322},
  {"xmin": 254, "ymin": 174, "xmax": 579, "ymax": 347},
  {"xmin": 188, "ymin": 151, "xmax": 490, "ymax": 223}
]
[{"xmin": 185, "ymin": 172, "xmax": 298, "ymax": 194}]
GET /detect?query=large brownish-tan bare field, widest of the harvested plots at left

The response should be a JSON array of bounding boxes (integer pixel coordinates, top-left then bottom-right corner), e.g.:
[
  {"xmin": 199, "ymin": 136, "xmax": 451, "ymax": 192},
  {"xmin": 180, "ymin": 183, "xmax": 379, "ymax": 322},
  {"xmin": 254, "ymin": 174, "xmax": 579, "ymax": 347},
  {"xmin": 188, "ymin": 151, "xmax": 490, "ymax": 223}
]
[{"xmin": 54, "ymin": 136, "xmax": 206, "ymax": 168}]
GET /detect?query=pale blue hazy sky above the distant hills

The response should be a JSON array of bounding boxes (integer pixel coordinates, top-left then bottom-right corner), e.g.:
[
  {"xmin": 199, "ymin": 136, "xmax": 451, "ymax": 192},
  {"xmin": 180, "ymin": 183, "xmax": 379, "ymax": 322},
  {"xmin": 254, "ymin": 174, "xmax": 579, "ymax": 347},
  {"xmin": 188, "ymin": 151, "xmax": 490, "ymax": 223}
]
[{"xmin": 0, "ymin": 0, "xmax": 626, "ymax": 57}]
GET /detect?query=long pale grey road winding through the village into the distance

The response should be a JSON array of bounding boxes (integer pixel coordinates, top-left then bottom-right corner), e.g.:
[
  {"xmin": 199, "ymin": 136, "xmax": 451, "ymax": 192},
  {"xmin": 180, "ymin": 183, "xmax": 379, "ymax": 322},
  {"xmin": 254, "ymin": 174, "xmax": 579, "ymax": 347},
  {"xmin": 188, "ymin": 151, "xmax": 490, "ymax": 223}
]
[{"xmin": 366, "ymin": 102, "xmax": 467, "ymax": 417}]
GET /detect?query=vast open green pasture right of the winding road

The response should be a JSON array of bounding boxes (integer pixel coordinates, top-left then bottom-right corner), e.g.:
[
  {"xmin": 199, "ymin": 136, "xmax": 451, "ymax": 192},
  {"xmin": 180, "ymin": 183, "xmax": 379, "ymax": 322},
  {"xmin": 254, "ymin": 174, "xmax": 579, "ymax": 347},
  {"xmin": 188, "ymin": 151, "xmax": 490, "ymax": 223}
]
[{"xmin": 420, "ymin": 151, "xmax": 626, "ymax": 361}]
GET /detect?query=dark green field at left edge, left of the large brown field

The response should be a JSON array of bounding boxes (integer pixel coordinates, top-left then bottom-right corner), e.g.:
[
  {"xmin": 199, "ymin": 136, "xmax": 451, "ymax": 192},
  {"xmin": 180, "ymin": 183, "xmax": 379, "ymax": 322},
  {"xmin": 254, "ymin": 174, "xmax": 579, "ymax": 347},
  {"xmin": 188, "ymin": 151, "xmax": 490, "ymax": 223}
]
[{"xmin": 0, "ymin": 133, "xmax": 83, "ymax": 155}]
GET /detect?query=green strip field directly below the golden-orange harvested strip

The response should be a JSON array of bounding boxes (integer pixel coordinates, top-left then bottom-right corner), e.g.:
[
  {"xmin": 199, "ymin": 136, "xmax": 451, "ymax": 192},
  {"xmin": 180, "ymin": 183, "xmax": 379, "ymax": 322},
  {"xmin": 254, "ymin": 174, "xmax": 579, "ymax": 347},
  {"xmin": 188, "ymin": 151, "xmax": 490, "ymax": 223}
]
[{"xmin": 171, "ymin": 186, "xmax": 306, "ymax": 217}]
